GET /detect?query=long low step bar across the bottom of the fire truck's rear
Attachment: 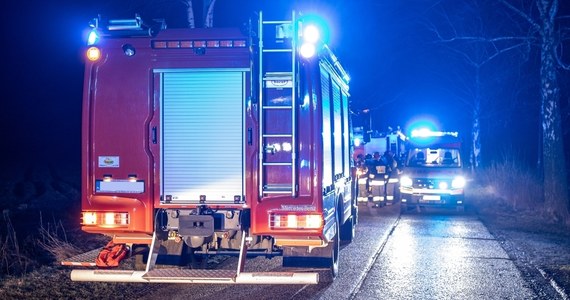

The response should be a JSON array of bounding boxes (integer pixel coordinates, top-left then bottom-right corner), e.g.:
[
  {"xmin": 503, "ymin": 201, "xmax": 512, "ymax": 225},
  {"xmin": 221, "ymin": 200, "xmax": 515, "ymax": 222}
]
[{"xmin": 71, "ymin": 269, "xmax": 319, "ymax": 284}]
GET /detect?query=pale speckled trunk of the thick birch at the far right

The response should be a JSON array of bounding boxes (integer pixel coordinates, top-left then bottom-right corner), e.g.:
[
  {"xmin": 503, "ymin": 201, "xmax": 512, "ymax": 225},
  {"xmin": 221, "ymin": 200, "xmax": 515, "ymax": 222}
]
[{"xmin": 538, "ymin": 0, "xmax": 570, "ymax": 223}]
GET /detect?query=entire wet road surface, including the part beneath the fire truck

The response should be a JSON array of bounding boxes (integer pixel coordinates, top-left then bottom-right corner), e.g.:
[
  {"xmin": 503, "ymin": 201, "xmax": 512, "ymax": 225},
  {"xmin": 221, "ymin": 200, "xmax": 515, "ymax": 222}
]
[{"xmin": 137, "ymin": 205, "xmax": 536, "ymax": 300}]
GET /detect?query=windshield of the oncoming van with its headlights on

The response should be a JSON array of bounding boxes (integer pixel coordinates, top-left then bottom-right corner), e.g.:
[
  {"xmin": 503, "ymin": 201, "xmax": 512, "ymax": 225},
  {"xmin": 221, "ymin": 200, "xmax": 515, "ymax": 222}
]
[{"xmin": 406, "ymin": 148, "xmax": 461, "ymax": 168}]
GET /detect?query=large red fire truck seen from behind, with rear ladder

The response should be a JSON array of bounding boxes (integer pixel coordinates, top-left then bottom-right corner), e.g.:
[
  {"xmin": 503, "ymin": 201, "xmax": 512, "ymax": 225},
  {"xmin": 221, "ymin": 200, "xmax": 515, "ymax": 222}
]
[{"xmin": 62, "ymin": 12, "xmax": 358, "ymax": 284}]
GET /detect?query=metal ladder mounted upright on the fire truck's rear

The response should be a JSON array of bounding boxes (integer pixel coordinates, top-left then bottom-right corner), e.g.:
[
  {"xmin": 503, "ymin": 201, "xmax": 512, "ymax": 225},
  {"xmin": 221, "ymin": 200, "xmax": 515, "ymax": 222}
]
[{"xmin": 258, "ymin": 11, "xmax": 297, "ymax": 197}]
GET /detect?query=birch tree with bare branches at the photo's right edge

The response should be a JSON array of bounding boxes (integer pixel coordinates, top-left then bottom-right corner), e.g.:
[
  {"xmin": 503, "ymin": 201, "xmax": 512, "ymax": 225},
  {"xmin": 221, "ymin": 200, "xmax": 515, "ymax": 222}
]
[{"xmin": 500, "ymin": 0, "xmax": 570, "ymax": 224}]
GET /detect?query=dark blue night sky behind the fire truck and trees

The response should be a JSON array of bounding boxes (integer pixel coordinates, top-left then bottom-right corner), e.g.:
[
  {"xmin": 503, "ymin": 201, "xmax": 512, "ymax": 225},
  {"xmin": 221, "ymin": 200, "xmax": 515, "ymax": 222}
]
[{"xmin": 0, "ymin": 0, "xmax": 570, "ymax": 167}]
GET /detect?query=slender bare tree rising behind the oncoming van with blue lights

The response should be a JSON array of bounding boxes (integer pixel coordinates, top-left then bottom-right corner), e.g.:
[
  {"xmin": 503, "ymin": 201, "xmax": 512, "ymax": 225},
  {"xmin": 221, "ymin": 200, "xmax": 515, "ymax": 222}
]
[{"xmin": 427, "ymin": 0, "xmax": 530, "ymax": 171}]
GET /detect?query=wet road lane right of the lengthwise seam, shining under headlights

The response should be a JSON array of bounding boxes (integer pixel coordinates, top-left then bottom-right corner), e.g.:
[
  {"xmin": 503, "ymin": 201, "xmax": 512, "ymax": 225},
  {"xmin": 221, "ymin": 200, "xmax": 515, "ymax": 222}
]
[{"xmin": 355, "ymin": 206, "xmax": 535, "ymax": 299}]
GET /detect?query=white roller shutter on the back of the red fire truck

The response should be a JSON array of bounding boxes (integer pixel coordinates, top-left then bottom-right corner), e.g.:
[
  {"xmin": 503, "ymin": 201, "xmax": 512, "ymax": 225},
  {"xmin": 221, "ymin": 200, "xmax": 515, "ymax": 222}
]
[{"xmin": 161, "ymin": 71, "xmax": 244, "ymax": 203}]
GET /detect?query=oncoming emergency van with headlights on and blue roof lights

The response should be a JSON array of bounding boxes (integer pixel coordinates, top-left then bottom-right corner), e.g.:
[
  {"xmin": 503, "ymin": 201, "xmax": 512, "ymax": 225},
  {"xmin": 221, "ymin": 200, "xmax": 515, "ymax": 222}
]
[{"xmin": 400, "ymin": 129, "xmax": 466, "ymax": 212}]
